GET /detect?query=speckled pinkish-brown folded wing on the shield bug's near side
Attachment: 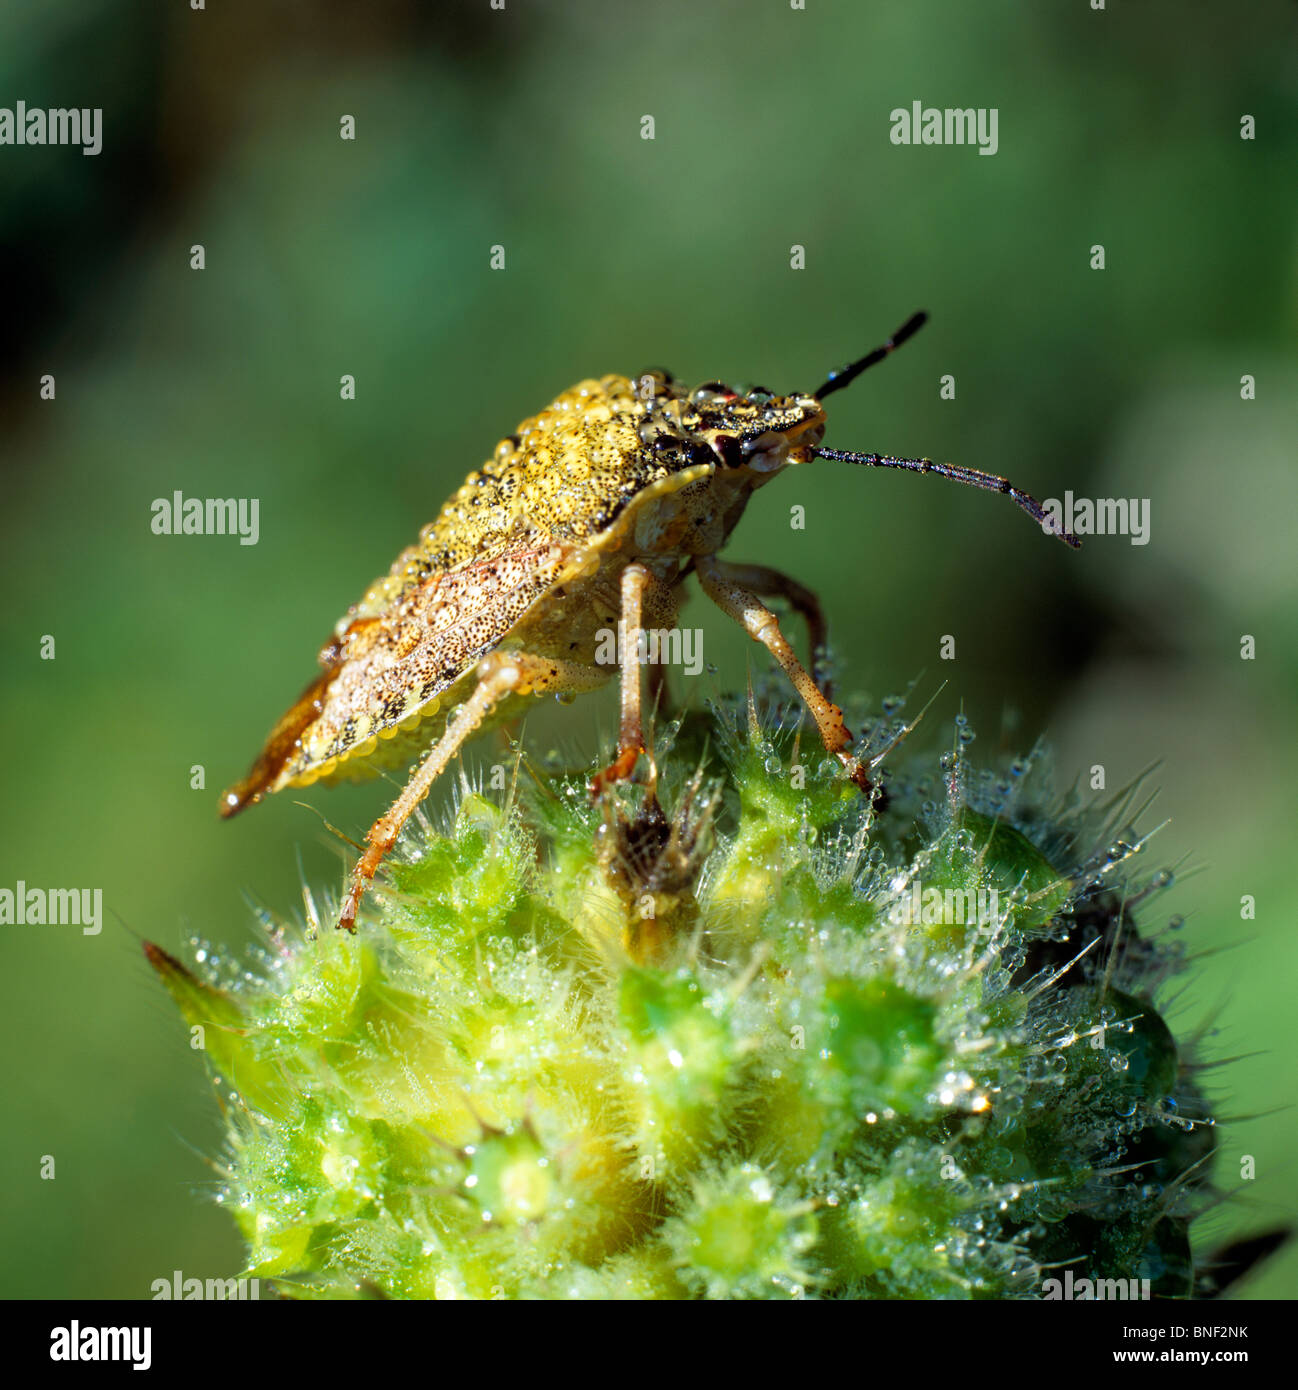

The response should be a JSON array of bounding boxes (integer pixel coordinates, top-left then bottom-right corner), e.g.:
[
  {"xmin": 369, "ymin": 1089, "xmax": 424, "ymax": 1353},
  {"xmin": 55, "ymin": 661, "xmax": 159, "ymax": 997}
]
[{"xmin": 221, "ymin": 541, "xmax": 580, "ymax": 816}]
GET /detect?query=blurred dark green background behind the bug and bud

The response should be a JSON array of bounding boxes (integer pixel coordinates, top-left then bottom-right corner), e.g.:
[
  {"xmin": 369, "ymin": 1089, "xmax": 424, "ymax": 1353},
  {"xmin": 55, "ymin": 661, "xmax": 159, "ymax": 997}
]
[{"xmin": 0, "ymin": 0, "xmax": 1298, "ymax": 1297}]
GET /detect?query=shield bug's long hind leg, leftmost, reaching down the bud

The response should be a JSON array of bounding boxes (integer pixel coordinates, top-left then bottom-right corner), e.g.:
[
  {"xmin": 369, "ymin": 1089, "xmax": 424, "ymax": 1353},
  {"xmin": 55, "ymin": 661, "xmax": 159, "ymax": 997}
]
[{"xmin": 338, "ymin": 652, "xmax": 609, "ymax": 931}]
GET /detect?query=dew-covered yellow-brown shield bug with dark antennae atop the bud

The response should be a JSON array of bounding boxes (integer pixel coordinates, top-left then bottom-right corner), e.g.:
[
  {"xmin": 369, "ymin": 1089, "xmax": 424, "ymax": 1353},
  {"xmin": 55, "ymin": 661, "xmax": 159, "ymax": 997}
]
[{"xmin": 221, "ymin": 314, "xmax": 1078, "ymax": 930}]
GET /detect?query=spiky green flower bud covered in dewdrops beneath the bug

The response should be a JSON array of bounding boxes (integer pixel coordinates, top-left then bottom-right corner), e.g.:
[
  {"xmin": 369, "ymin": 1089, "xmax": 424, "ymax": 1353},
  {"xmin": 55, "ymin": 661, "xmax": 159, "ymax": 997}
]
[{"xmin": 147, "ymin": 708, "xmax": 1239, "ymax": 1298}]
